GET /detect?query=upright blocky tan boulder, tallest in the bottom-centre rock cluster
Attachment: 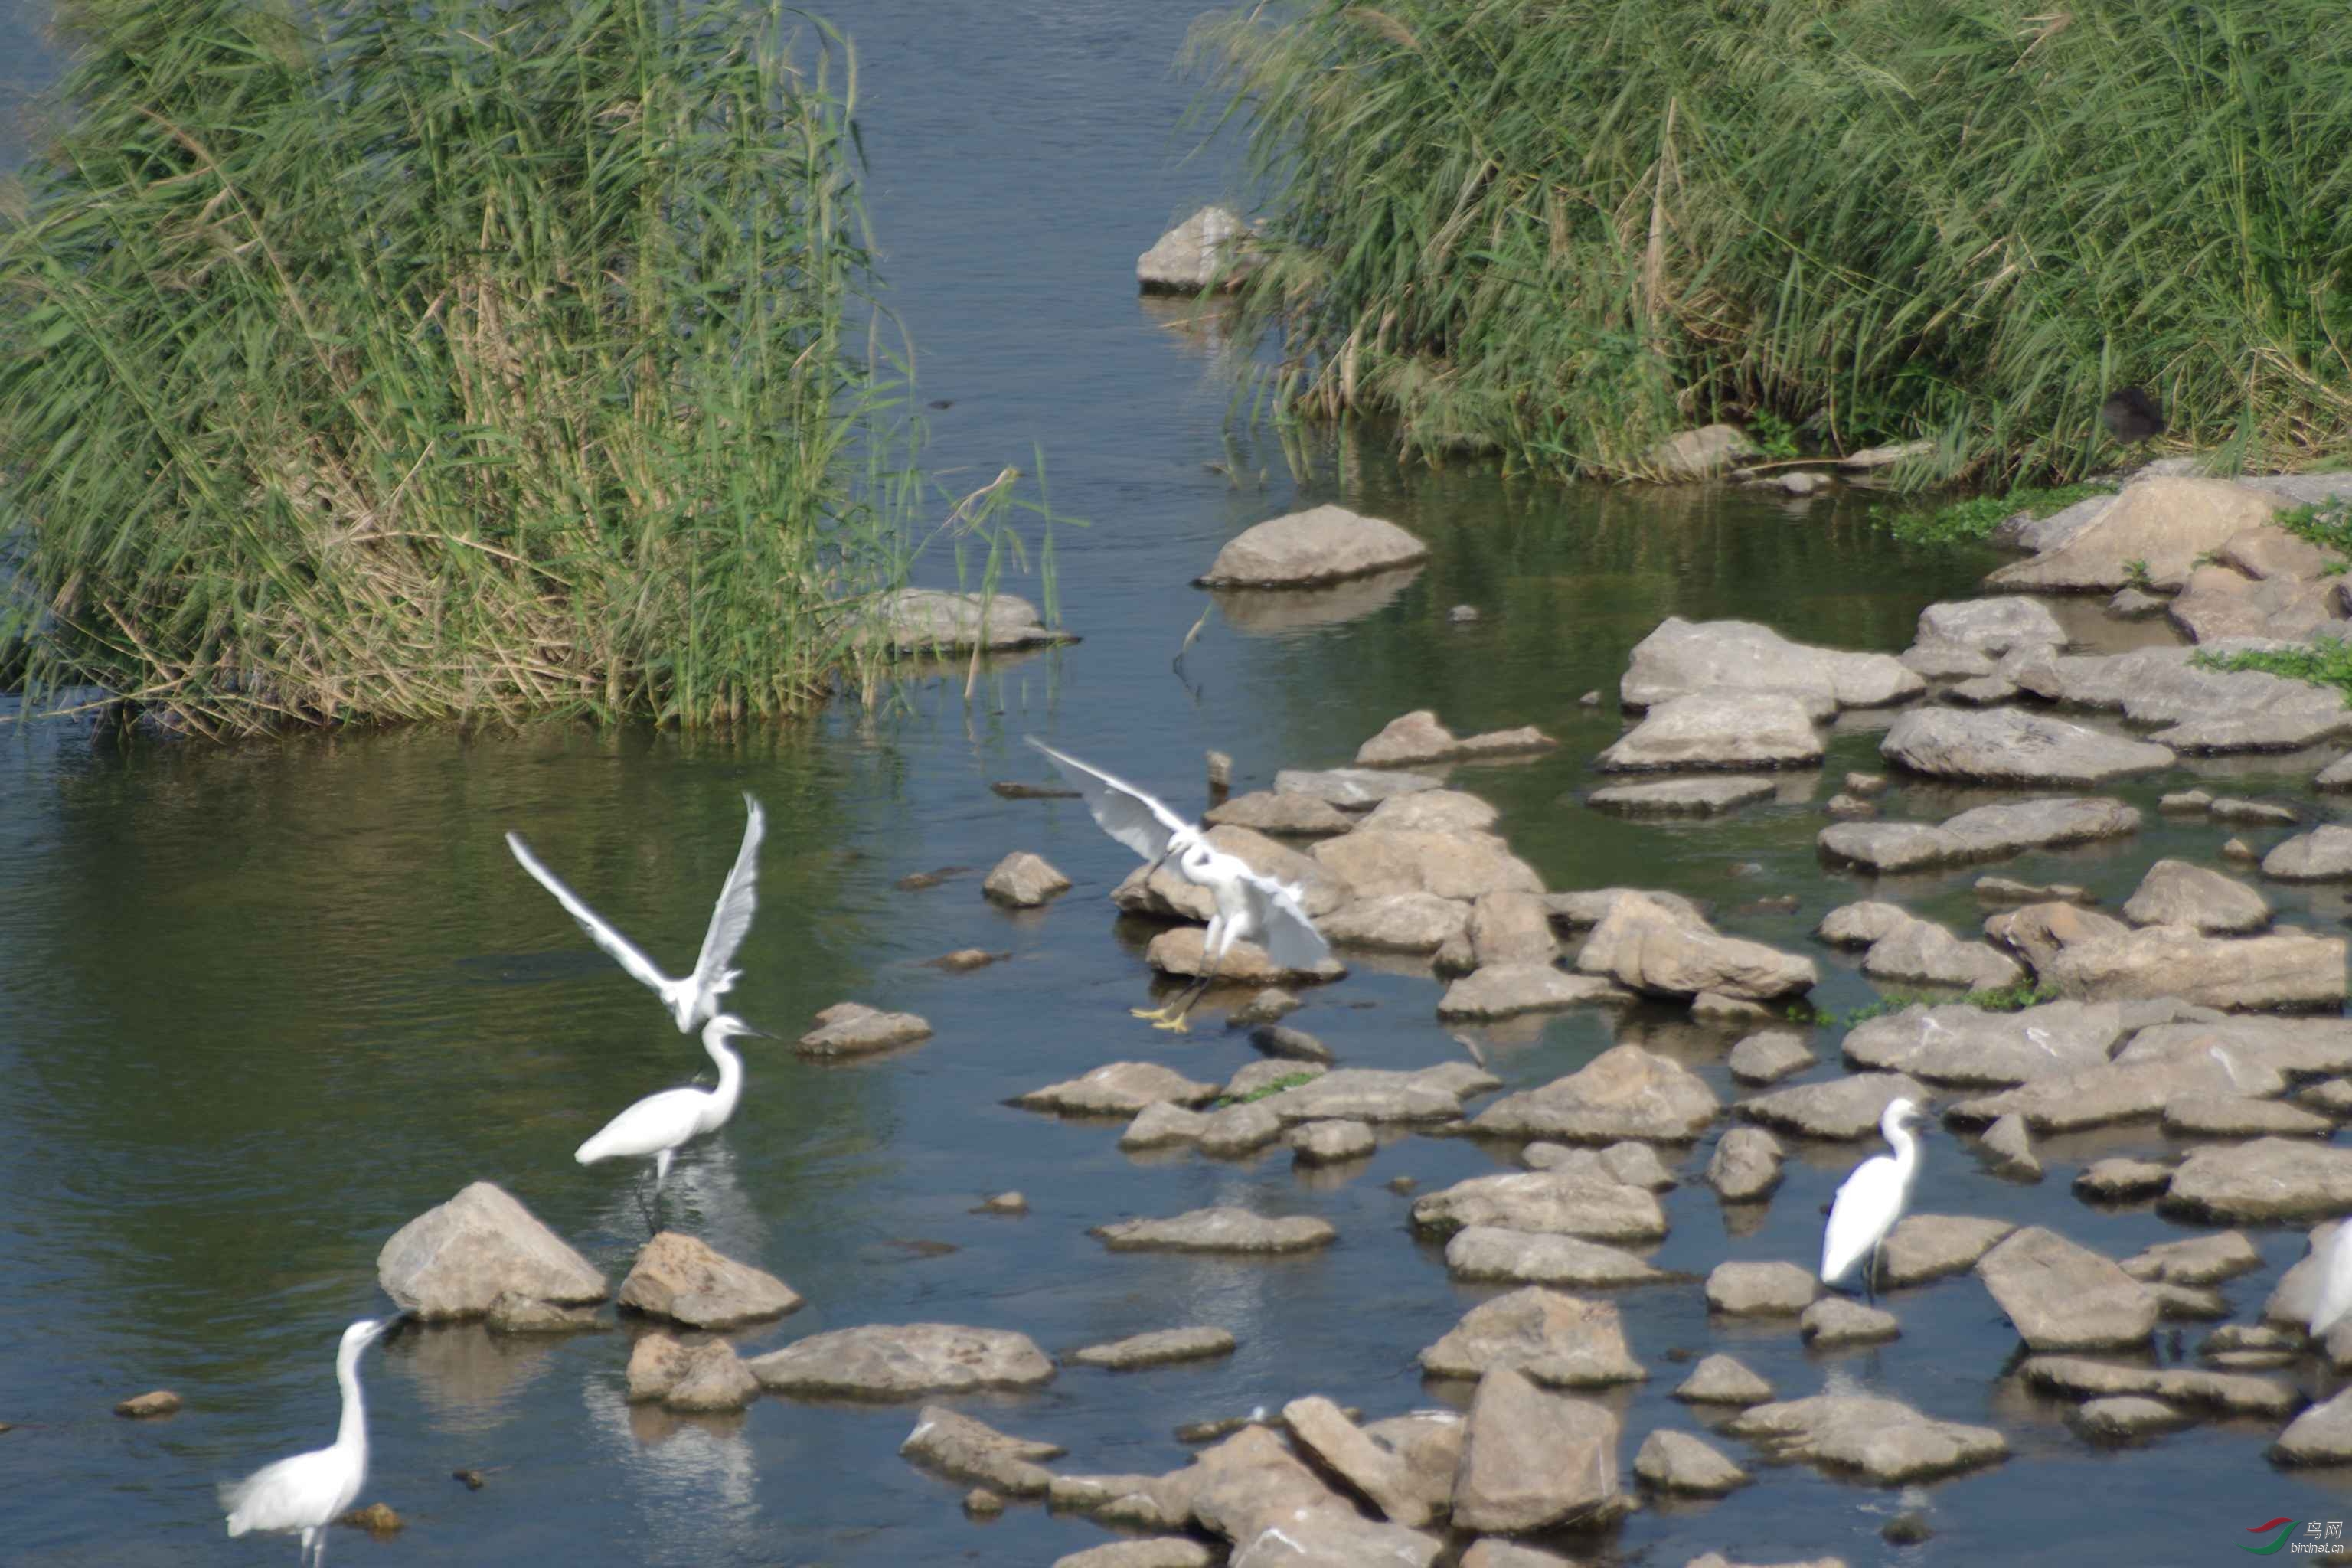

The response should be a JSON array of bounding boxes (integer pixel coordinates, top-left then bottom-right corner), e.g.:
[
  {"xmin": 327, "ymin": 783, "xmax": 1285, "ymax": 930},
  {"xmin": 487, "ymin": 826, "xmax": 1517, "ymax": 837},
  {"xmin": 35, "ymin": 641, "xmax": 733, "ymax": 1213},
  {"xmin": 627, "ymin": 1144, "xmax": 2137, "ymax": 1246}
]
[{"xmin": 1449, "ymin": 1366, "xmax": 1625, "ymax": 1532}]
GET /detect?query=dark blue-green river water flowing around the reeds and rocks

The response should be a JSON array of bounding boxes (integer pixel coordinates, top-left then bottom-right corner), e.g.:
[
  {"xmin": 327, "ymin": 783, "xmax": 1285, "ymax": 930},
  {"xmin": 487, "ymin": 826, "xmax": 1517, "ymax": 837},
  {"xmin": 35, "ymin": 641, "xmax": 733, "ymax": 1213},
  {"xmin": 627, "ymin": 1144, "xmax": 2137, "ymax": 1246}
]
[{"xmin": 0, "ymin": 2, "xmax": 2352, "ymax": 1568}]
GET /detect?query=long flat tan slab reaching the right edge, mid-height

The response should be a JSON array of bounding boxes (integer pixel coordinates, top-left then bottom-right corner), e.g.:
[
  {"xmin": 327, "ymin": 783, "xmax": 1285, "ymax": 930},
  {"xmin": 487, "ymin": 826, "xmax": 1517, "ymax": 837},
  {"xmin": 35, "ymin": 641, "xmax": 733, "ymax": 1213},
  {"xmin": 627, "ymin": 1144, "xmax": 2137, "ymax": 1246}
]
[{"xmin": 2041, "ymin": 926, "xmax": 2345, "ymax": 1008}]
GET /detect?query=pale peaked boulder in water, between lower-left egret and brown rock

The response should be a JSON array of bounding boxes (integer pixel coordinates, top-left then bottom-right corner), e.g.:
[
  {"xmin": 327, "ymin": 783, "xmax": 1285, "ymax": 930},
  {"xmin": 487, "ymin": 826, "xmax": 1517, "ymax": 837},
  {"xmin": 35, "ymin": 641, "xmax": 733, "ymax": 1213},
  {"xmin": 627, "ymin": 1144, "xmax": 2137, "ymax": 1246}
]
[{"xmin": 377, "ymin": 1182, "xmax": 607, "ymax": 1321}]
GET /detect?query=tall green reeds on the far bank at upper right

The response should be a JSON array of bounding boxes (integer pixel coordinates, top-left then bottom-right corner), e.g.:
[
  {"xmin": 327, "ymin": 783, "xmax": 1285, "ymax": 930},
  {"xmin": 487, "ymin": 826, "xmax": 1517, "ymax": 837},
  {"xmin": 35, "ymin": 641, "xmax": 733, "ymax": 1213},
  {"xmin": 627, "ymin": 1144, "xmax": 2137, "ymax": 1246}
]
[{"xmin": 1193, "ymin": 0, "xmax": 2352, "ymax": 489}]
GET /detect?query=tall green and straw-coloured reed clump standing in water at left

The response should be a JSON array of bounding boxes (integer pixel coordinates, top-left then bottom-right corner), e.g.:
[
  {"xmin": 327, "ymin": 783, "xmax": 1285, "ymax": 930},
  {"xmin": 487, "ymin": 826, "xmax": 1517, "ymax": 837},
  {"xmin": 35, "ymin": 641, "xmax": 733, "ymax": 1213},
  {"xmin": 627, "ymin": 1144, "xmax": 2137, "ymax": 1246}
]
[{"xmin": 0, "ymin": 0, "xmax": 1039, "ymax": 736}]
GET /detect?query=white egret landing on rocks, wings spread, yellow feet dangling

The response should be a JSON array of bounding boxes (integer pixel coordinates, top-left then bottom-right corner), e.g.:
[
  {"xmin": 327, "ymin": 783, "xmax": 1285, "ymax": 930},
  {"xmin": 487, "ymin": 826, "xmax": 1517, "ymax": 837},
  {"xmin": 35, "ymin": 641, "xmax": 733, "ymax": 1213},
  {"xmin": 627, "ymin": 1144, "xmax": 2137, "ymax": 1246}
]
[{"xmin": 1027, "ymin": 736, "xmax": 1331, "ymax": 1030}]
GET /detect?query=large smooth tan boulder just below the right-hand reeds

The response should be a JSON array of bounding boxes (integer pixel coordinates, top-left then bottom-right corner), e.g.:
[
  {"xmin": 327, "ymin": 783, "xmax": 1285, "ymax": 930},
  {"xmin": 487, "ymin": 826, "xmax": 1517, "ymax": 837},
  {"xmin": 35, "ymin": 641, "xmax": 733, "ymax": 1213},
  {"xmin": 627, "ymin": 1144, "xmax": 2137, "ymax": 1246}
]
[{"xmin": 1985, "ymin": 477, "xmax": 2286, "ymax": 593}]
